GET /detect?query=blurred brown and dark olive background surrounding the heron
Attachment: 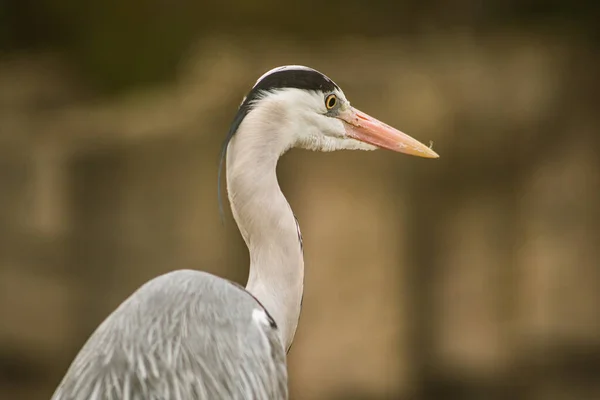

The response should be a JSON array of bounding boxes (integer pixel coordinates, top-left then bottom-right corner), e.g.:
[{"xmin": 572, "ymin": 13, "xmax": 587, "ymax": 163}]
[{"xmin": 0, "ymin": 0, "xmax": 600, "ymax": 400}]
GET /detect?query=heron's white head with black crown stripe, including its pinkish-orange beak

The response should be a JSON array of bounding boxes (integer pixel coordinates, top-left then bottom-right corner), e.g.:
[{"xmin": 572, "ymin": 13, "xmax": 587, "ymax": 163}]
[{"xmin": 230, "ymin": 65, "xmax": 438, "ymax": 158}]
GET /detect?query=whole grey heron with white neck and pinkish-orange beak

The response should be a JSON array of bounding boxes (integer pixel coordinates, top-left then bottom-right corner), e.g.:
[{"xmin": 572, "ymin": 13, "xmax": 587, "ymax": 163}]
[{"xmin": 52, "ymin": 65, "xmax": 438, "ymax": 400}]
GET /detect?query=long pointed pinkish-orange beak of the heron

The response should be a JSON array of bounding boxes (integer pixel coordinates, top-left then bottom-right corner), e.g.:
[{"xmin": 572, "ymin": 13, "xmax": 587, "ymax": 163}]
[{"xmin": 337, "ymin": 106, "xmax": 439, "ymax": 158}]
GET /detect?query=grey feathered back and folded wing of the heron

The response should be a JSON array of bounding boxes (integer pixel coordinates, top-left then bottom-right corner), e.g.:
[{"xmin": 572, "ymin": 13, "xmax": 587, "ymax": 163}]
[{"xmin": 52, "ymin": 270, "xmax": 288, "ymax": 400}]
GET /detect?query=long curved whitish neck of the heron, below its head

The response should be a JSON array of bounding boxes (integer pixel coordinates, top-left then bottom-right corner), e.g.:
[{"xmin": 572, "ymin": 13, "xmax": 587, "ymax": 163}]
[{"xmin": 227, "ymin": 104, "xmax": 304, "ymax": 350}]
